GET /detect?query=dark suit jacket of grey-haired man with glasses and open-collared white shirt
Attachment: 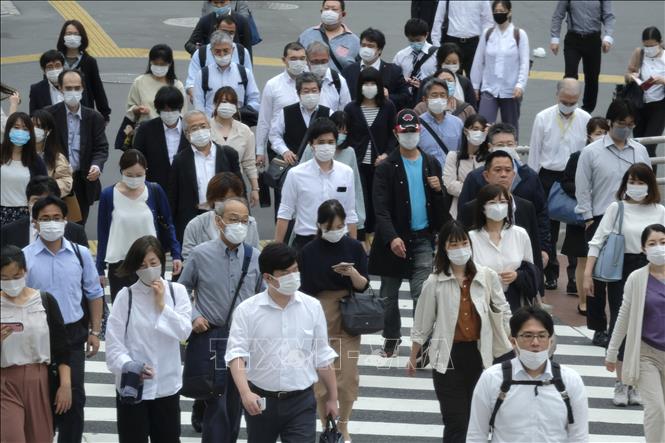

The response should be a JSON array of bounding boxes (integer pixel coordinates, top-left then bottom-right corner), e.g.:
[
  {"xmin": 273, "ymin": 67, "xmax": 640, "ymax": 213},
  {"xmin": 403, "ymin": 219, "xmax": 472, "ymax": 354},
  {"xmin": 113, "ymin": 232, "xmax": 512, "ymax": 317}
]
[{"xmin": 169, "ymin": 143, "xmax": 242, "ymax": 243}]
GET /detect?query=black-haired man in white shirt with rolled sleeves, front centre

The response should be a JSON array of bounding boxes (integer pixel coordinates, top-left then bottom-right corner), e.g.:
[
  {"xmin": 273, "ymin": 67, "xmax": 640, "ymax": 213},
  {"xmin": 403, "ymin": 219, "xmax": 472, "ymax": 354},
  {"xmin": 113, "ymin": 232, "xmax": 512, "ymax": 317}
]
[{"xmin": 225, "ymin": 243, "xmax": 338, "ymax": 443}]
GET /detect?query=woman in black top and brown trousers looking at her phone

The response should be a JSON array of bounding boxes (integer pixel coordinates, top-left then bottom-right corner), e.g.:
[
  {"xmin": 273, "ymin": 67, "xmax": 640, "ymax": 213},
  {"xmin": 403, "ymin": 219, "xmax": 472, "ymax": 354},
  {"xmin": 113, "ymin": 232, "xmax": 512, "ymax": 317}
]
[{"xmin": 298, "ymin": 199, "xmax": 369, "ymax": 441}]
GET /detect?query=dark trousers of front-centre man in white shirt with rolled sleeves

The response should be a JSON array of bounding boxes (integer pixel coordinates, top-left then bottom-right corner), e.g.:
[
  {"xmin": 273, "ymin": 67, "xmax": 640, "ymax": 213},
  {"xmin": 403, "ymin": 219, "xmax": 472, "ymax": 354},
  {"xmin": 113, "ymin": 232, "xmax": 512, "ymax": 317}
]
[{"xmin": 245, "ymin": 388, "xmax": 316, "ymax": 443}]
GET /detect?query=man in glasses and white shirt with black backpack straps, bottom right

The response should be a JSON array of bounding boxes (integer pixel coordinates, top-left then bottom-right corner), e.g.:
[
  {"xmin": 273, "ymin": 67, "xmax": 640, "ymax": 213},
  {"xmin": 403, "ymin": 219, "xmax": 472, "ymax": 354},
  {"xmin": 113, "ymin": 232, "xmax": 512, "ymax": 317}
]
[{"xmin": 466, "ymin": 307, "xmax": 589, "ymax": 443}]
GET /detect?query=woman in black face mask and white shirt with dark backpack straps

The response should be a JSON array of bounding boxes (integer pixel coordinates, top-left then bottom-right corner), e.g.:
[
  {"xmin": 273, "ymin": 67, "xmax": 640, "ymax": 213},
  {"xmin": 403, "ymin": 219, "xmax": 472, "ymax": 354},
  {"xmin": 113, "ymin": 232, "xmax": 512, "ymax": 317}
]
[{"xmin": 471, "ymin": 0, "xmax": 529, "ymax": 134}]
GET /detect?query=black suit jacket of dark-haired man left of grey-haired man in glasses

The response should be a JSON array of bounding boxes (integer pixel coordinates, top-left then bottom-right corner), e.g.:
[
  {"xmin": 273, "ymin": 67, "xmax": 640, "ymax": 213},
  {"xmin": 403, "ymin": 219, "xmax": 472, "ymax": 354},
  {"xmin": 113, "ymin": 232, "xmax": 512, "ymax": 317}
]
[{"xmin": 134, "ymin": 117, "xmax": 189, "ymax": 193}]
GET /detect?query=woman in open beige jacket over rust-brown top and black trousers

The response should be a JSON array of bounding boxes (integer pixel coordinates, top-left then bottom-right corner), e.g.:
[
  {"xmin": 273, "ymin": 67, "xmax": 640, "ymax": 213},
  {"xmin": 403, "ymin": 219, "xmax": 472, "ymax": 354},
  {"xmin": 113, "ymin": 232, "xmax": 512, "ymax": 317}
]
[{"xmin": 407, "ymin": 221, "xmax": 510, "ymax": 443}]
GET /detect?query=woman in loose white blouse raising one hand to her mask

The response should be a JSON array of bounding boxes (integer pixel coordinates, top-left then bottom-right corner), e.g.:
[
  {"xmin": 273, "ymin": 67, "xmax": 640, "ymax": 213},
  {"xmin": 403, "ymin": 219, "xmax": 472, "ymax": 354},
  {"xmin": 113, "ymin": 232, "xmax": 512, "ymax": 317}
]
[{"xmin": 106, "ymin": 236, "xmax": 192, "ymax": 443}]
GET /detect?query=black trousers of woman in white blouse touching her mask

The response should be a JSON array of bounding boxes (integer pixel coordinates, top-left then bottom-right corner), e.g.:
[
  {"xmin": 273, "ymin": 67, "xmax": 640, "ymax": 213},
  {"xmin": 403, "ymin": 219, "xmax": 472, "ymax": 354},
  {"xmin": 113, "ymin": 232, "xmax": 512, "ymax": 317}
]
[{"xmin": 115, "ymin": 393, "xmax": 180, "ymax": 443}]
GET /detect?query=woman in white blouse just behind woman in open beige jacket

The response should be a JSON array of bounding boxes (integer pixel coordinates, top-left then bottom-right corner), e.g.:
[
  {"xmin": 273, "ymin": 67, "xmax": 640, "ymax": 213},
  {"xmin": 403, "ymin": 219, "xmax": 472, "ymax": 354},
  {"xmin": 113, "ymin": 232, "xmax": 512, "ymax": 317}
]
[{"xmin": 469, "ymin": 185, "xmax": 533, "ymax": 312}]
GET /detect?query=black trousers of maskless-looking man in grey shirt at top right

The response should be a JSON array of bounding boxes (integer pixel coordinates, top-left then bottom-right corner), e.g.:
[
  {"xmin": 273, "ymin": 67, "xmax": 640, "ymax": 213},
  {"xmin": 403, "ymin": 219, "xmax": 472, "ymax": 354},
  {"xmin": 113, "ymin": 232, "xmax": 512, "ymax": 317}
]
[{"xmin": 563, "ymin": 32, "xmax": 602, "ymax": 114}]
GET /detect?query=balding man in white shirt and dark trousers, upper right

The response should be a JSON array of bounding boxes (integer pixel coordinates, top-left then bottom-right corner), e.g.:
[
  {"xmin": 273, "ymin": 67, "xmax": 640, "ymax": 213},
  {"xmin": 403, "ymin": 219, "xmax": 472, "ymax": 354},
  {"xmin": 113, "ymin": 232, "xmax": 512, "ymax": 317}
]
[{"xmin": 527, "ymin": 78, "xmax": 591, "ymax": 294}]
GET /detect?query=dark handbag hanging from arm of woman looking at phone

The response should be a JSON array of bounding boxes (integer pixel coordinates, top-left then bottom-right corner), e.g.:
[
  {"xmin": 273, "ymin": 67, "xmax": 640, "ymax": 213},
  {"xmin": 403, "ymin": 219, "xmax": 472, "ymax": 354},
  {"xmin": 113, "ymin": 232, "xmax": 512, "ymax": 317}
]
[{"xmin": 339, "ymin": 287, "xmax": 384, "ymax": 335}]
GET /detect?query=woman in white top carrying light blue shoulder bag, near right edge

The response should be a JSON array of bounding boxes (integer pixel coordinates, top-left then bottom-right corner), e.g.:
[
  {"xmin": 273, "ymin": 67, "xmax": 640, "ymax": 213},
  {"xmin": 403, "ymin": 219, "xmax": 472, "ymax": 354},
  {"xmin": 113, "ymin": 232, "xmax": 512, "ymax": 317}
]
[{"xmin": 584, "ymin": 163, "xmax": 665, "ymax": 406}]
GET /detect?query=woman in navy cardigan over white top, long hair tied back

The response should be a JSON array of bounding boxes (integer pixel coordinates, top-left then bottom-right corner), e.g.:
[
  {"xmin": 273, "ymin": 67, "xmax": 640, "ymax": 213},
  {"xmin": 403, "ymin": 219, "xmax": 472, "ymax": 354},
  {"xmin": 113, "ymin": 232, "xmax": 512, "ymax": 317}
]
[{"xmin": 97, "ymin": 149, "xmax": 182, "ymax": 302}]
